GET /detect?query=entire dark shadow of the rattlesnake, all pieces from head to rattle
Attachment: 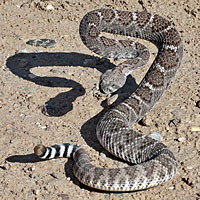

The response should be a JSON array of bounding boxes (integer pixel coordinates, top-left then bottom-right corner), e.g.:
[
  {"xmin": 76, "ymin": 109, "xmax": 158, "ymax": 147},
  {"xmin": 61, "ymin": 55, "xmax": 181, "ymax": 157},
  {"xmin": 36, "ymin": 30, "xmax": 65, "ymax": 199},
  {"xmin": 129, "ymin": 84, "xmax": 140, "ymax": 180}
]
[{"xmin": 6, "ymin": 52, "xmax": 138, "ymax": 192}]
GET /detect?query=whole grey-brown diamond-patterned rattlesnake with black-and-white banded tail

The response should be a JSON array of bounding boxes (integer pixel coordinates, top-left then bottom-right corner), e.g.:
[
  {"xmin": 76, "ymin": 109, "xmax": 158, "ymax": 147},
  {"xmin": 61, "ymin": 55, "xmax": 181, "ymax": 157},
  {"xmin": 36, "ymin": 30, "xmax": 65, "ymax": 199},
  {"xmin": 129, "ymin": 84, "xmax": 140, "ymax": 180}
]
[{"xmin": 34, "ymin": 9, "xmax": 183, "ymax": 191}]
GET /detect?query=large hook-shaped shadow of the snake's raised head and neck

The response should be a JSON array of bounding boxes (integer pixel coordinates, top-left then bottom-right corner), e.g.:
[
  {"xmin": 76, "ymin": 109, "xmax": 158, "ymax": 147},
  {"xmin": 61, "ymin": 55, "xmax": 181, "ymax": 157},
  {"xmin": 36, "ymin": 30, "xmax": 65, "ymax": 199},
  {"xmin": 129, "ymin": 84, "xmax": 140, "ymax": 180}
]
[{"xmin": 6, "ymin": 52, "xmax": 112, "ymax": 117}]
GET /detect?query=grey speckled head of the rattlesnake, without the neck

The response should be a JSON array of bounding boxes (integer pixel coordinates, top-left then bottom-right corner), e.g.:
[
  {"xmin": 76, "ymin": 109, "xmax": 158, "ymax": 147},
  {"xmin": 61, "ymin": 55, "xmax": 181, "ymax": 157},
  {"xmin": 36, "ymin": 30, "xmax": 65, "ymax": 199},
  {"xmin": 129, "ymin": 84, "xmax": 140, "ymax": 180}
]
[{"xmin": 99, "ymin": 68, "xmax": 126, "ymax": 94}]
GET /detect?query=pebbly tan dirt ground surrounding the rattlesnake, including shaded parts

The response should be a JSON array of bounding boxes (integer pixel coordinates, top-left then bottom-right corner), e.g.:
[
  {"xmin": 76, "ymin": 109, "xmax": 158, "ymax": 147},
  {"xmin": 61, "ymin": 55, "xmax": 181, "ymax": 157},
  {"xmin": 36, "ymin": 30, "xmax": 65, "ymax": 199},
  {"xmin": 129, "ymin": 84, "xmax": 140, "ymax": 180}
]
[{"xmin": 0, "ymin": 0, "xmax": 200, "ymax": 200}]
